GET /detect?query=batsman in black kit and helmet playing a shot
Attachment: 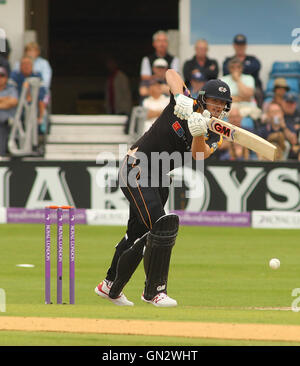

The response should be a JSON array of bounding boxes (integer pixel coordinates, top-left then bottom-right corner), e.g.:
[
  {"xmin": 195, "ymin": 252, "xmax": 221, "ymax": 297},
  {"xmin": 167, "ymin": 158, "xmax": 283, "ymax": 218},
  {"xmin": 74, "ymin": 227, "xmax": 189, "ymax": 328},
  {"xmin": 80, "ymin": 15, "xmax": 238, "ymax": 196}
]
[{"xmin": 95, "ymin": 69, "xmax": 232, "ymax": 307}]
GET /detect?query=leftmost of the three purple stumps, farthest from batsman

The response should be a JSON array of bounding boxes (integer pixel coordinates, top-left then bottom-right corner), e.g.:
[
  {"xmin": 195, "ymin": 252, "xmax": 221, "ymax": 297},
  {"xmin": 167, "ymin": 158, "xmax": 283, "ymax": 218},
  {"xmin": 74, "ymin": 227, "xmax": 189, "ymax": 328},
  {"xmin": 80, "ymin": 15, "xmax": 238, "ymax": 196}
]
[{"xmin": 45, "ymin": 207, "xmax": 51, "ymax": 304}]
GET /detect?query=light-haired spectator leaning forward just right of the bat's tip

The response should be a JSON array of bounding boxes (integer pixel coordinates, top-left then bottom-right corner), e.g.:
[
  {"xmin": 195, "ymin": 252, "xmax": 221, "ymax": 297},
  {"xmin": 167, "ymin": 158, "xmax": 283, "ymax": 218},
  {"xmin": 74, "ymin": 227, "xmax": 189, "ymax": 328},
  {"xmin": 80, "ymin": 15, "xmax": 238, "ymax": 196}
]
[{"xmin": 257, "ymin": 102, "xmax": 297, "ymax": 160}]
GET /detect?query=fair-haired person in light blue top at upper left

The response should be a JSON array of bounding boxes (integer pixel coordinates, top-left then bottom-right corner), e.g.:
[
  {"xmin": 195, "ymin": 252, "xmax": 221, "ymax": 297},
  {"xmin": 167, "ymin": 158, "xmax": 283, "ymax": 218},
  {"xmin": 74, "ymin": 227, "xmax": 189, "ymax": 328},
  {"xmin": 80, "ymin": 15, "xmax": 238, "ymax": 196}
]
[{"xmin": 13, "ymin": 42, "xmax": 52, "ymax": 92}]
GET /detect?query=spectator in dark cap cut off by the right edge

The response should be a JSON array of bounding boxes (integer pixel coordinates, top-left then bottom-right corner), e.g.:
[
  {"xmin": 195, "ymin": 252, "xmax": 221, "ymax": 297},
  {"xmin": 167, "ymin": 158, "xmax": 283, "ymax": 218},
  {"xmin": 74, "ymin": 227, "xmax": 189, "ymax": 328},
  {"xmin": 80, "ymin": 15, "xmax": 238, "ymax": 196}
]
[{"xmin": 283, "ymin": 93, "xmax": 300, "ymax": 160}]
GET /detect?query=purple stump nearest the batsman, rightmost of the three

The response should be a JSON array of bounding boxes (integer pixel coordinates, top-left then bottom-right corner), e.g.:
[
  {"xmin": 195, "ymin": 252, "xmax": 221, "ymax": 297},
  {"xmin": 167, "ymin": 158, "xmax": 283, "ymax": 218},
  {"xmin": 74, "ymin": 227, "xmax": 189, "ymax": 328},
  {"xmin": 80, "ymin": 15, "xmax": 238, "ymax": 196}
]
[{"xmin": 69, "ymin": 207, "xmax": 75, "ymax": 304}]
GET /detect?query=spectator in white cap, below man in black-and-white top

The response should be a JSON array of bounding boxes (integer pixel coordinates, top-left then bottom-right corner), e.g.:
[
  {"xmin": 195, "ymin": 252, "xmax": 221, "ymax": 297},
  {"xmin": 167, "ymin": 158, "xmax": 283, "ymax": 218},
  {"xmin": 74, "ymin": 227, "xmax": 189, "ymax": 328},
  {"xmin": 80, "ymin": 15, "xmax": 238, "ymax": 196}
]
[{"xmin": 139, "ymin": 58, "xmax": 170, "ymax": 104}]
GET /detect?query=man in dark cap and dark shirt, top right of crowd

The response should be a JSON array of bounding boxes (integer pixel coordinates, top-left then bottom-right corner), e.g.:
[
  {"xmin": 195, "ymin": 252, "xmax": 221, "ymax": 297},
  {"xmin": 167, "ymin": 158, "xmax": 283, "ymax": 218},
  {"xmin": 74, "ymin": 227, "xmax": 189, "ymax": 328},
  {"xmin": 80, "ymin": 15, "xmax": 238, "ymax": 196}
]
[{"xmin": 223, "ymin": 34, "xmax": 263, "ymax": 108}]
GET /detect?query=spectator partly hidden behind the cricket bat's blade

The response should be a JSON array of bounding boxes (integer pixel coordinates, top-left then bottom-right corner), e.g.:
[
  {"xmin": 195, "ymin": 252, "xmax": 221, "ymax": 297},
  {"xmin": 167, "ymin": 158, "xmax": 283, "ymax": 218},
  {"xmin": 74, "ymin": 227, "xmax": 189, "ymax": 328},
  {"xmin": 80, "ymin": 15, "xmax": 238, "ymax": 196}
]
[{"xmin": 219, "ymin": 107, "xmax": 251, "ymax": 160}]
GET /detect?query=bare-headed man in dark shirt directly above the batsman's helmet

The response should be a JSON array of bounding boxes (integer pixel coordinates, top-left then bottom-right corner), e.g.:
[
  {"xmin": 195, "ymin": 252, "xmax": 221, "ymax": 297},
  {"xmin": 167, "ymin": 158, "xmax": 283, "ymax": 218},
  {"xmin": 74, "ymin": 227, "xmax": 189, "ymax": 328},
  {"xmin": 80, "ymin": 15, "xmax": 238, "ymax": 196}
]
[{"xmin": 183, "ymin": 39, "xmax": 219, "ymax": 87}]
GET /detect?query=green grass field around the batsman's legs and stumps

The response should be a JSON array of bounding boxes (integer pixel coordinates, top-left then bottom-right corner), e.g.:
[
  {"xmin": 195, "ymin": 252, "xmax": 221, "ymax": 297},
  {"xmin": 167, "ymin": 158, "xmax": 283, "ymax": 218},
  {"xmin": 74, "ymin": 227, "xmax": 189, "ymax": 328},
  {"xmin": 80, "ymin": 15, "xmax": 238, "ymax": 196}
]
[{"xmin": 0, "ymin": 224, "xmax": 300, "ymax": 346}]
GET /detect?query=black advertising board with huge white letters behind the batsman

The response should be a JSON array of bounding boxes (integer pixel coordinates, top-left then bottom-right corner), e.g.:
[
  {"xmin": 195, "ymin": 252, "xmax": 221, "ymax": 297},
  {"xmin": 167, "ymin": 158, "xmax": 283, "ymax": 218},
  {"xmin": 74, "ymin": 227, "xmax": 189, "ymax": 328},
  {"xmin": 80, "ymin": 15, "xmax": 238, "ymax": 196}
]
[{"xmin": 0, "ymin": 161, "xmax": 300, "ymax": 212}]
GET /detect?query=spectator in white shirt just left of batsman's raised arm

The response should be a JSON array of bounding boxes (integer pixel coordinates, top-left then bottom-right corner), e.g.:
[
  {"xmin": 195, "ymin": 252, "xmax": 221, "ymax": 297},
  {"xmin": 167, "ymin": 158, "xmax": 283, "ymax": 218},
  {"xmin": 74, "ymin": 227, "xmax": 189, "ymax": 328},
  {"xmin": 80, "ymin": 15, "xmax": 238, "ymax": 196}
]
[{"xmin": 143, "ymin": 79, "xmax": 170, "ymax": 132}]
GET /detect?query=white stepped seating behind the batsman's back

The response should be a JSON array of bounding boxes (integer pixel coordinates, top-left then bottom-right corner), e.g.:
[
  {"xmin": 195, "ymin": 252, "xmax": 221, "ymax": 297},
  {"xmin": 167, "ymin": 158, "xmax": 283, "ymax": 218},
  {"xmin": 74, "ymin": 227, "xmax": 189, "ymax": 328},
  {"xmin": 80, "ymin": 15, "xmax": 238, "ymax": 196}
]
[{"xmin": 45, "ymin": 107, "xmax": 145, "ymax": 161}]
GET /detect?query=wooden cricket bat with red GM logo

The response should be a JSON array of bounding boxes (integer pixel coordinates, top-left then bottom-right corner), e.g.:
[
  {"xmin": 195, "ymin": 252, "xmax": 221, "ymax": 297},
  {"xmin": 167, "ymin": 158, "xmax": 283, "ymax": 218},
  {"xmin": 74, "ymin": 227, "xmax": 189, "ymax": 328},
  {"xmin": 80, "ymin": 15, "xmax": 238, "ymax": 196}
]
[{"xmin": 208, "ymin": 117, "xmax": 277, "ymax": 161}]
